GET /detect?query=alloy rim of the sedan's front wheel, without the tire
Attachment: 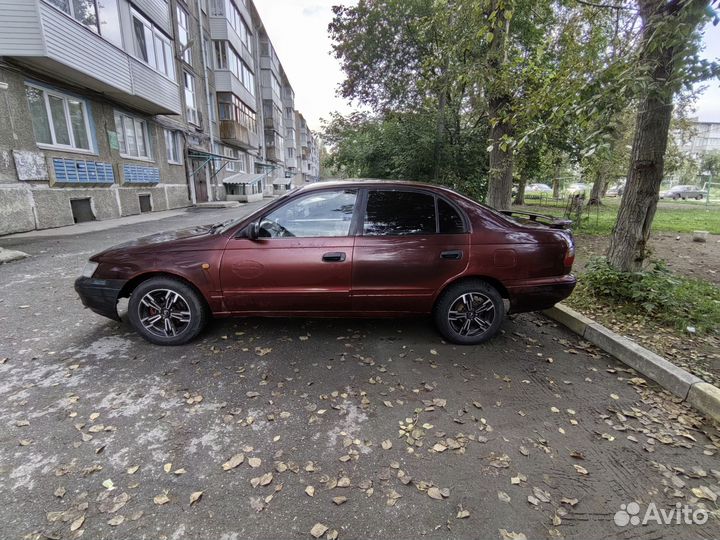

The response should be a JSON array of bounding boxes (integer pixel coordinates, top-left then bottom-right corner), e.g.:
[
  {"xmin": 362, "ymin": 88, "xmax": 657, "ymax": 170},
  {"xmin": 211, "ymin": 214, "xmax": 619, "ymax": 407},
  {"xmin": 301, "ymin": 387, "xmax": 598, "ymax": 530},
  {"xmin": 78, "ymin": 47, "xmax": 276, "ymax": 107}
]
[{"xmin": 138, "ymin": 289, "xmax": 192, "ymax": 338}]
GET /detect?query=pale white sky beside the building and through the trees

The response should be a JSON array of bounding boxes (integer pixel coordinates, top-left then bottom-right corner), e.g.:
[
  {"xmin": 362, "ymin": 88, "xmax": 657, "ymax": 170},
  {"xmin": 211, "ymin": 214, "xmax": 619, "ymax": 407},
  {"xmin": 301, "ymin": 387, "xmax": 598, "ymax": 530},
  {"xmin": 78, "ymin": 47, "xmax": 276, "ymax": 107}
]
[{"xmin": 255, "ymin": 0, "xmax": 720, "ymax": 131}]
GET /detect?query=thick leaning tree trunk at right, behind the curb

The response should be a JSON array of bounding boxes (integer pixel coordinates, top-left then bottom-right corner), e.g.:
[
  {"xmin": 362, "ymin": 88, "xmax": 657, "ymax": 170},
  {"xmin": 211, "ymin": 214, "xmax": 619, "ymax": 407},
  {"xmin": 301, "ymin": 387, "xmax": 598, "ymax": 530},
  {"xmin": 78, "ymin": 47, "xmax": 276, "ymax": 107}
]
[{"xmin": 608, "ymin": 0, "xmax": 689, "ymax": 272}]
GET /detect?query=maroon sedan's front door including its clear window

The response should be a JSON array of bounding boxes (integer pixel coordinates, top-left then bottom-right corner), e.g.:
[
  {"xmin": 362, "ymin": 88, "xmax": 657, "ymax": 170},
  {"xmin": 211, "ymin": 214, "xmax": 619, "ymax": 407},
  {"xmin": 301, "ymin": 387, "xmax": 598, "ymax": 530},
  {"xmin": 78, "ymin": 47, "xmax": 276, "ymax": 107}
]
[{"xmin": 220, "ymin": 189, "xmax": 358, "ymax": 314}]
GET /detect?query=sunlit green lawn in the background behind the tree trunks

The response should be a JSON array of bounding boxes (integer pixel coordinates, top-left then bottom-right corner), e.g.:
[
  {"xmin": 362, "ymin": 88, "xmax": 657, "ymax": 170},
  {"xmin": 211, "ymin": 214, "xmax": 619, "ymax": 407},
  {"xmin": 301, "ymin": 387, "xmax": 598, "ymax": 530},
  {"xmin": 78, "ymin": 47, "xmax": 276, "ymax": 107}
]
[{"xmin": 513, "ymin": 198, "xmax": 720, "ymax": 234}]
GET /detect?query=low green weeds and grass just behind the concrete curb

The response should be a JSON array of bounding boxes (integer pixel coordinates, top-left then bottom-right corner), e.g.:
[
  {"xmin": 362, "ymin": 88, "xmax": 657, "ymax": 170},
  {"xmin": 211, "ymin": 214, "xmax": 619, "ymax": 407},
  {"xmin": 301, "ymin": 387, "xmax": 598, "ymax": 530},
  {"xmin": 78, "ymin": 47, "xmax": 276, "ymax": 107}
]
[{"xmin": 580, "ymin": 257, "xmax": 720, "ymax": 333}]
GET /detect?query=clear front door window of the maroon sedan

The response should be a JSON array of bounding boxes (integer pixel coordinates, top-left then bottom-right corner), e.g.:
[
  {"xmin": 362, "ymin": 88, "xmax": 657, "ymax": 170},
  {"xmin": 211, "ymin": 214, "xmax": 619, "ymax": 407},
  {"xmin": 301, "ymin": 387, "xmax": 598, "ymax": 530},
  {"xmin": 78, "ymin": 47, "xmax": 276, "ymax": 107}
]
[{"xmin": 259, "ymin": 189, "xmax": 357, "ymax": 238}]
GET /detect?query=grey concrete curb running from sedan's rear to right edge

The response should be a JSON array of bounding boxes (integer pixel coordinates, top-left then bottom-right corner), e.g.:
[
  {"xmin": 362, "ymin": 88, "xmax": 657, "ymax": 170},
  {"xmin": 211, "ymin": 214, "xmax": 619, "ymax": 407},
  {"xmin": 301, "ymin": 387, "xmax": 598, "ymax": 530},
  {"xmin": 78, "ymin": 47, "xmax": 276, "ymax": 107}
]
[{"xmin": 543, "ymin": 304, "xmax": 720, "ymax": 423}]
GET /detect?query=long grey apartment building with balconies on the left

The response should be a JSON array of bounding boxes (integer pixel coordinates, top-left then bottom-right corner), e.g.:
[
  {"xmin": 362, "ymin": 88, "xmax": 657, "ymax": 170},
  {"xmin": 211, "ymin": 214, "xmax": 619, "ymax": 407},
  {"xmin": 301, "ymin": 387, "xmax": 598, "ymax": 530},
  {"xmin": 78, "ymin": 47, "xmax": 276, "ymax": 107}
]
[{"xmin": 0, "ymin": 0, "xmax": 320, "ymax": 234}]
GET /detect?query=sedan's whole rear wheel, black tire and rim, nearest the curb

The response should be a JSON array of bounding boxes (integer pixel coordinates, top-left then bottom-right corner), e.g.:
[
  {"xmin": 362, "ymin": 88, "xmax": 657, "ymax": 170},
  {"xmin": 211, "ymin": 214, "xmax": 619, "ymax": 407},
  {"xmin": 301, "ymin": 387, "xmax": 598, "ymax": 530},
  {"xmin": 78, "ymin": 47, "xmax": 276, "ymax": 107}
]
[{"xmin": 433, "ymin": 280, "xmax": 505, "ymax": 345}]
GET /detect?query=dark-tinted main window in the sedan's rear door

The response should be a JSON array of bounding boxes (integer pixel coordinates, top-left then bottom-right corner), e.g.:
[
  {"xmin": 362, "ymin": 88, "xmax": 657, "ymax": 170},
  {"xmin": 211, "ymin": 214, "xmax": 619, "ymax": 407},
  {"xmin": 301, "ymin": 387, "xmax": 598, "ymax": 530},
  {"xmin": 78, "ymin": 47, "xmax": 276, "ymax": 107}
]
[{"xmin": 363, "ymin": 190, "xmax": 437, "ymax": 236}]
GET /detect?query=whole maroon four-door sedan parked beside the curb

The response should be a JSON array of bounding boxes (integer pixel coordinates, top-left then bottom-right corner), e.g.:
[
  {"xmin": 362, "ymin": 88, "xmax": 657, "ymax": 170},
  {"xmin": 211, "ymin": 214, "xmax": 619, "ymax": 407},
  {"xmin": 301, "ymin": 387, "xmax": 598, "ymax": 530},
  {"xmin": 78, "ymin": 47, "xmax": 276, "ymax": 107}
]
[{"xmin": 75, "ymin": 181, "xmax": 575, "ymax": 345}]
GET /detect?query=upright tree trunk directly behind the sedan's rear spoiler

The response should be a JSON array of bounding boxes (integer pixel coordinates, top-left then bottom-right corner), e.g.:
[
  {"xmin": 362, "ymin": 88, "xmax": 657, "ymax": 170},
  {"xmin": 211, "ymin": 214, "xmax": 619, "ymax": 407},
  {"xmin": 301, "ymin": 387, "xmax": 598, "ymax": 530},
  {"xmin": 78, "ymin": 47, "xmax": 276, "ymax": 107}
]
[{"xmin": 486, "ymin": 96, "xmax": 513, "ymax": 210}]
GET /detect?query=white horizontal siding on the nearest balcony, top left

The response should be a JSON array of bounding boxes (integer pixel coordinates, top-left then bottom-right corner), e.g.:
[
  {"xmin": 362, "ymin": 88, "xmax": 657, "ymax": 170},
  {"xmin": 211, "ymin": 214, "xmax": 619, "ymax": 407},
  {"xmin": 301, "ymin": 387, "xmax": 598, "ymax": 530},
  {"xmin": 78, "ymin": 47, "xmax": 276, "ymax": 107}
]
[{"xmin": 0, "ymin": 0, "xmax": 182, "ymax": 114}]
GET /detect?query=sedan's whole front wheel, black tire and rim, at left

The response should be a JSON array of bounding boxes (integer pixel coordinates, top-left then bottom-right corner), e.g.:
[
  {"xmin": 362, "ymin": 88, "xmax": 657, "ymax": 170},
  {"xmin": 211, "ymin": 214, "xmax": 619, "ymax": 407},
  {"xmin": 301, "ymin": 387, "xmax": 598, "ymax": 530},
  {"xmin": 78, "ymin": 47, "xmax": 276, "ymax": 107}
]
[{"xmin": 128, "ymin": 277, "xmax": 208, "ymax": 345}]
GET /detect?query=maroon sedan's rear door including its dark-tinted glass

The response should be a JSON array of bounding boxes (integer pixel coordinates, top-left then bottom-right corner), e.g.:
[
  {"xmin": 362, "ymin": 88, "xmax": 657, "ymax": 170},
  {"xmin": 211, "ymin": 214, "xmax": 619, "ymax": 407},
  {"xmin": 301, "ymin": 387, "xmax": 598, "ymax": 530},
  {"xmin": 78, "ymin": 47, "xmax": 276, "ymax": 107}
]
[{"xmin": 351, "ymin": 188, "xmax": 470, "ymax": 313}]
